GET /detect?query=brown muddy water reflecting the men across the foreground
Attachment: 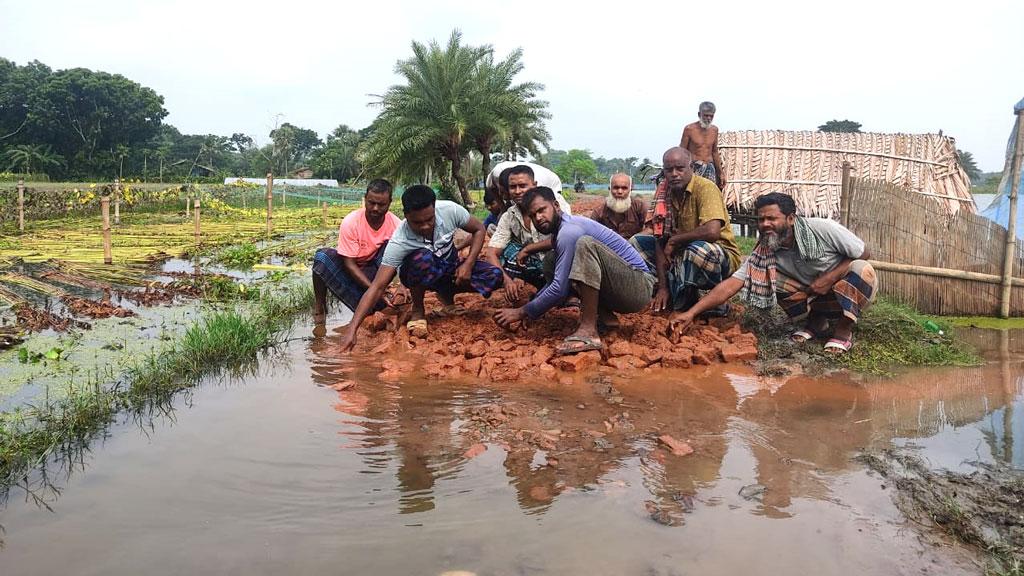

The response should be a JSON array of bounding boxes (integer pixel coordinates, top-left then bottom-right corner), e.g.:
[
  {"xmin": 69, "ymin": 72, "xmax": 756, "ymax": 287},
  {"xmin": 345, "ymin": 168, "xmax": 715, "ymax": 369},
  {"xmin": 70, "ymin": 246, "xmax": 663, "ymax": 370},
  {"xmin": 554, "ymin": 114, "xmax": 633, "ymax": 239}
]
[{"xmin": 0, "ymin": 327, "xmax": 1024, "ymax": 575}]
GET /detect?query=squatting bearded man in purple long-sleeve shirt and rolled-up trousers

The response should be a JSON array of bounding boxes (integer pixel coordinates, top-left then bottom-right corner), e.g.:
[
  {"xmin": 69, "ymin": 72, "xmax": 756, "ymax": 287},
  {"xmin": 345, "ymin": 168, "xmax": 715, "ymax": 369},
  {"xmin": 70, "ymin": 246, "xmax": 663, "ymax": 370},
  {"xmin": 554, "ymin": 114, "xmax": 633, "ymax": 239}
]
[{"xmin": 495, "ymin": 187, "xmax": 654, "ymax": 355}]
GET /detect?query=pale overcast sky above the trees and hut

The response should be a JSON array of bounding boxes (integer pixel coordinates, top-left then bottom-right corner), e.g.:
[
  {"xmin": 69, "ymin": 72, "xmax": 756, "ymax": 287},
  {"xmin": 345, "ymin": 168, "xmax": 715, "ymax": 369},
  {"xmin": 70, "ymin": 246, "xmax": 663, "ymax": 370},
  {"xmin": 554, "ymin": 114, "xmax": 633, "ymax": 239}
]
[{"xmin": 0, "ymin": 0, "xmax": 1024, "ymax": 171}]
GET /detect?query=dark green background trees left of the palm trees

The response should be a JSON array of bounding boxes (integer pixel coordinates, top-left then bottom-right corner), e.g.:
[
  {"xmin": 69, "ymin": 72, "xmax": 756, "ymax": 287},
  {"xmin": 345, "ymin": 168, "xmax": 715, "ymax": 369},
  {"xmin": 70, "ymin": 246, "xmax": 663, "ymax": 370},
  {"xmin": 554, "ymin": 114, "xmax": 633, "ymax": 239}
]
[{"xmin": 0, "ymin": 58, "xmax": 376, "ymax": 180}]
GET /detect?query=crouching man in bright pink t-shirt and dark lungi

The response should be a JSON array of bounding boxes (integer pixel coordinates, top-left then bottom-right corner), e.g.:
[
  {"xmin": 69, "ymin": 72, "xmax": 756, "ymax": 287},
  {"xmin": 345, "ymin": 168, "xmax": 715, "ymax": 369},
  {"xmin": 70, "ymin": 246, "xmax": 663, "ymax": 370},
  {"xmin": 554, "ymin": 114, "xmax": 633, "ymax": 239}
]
[{"xmin": 313, "ymin": 178, "xmax": 401, "ymax": 324}]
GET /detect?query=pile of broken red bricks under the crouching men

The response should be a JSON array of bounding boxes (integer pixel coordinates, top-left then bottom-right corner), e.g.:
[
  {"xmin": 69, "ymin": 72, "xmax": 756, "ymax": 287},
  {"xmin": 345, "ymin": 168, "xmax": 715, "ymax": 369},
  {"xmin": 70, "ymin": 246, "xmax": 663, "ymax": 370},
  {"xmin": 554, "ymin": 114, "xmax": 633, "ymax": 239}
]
[{"xmin": 356, "ymin": 293, "xmax": 758, "ymax": 381}]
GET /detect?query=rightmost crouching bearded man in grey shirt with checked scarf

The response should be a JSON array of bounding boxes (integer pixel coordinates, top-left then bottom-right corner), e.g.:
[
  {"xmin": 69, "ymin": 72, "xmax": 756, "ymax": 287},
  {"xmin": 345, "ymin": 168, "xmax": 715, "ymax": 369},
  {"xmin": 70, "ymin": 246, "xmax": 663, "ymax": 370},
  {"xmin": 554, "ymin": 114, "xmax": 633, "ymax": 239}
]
[{"xmin": 672, "ymin": 193, "xmax": 879, "ymax": 354}]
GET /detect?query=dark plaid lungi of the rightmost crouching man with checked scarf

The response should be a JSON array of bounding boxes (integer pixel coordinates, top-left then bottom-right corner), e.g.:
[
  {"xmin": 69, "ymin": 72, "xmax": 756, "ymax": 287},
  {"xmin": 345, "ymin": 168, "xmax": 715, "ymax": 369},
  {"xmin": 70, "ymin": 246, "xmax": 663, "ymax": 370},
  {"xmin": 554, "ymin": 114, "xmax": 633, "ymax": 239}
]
[{"xmin": 775, "ymin": 260, "xmax": 879, "ymax": 322}]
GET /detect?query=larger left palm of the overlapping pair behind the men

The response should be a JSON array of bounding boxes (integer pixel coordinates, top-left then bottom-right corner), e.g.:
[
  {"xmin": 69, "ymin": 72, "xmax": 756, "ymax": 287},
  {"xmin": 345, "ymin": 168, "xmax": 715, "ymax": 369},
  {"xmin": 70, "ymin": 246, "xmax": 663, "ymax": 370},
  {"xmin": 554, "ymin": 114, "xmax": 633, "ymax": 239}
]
[{"xmin": 361, "ymin": 30, "xmax": 493, "ymax": 206}]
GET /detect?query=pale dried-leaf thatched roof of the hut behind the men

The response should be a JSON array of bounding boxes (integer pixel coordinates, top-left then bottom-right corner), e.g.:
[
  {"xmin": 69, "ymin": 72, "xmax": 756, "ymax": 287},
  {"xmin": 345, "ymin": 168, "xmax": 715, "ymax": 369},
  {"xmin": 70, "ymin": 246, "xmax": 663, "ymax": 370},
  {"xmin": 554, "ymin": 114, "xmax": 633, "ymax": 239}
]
[{"xmin": 718, "ymin": 130, "xmax": 976, "ymax": 217}]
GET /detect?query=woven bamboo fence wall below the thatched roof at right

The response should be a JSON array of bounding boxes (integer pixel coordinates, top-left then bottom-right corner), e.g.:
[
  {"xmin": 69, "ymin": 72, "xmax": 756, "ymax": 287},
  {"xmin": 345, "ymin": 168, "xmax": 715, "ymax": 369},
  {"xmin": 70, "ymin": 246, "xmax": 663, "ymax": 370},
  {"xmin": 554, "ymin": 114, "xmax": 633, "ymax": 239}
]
[{"xmin": 850, "ymin": 178, "xmax": 1024, "ymax": 316}]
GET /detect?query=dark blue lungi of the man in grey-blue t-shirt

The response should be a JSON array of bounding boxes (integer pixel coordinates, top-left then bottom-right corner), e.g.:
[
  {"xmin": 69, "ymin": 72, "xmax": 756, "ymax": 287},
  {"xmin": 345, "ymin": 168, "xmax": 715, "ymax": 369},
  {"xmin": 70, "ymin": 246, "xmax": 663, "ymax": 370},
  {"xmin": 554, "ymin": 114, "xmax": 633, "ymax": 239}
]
[{"xmin": 398, "ymin": 248, "xmax": 503, "ymax": 298}]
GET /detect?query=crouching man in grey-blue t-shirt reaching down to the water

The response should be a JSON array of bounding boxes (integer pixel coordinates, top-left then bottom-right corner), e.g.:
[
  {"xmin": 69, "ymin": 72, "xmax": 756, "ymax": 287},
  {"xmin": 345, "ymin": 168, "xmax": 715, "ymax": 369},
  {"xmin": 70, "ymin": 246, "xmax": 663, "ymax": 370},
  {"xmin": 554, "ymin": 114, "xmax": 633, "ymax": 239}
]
[{"xmin": 342, "ymin": 184, "xmax": 502, "ymax": 352}]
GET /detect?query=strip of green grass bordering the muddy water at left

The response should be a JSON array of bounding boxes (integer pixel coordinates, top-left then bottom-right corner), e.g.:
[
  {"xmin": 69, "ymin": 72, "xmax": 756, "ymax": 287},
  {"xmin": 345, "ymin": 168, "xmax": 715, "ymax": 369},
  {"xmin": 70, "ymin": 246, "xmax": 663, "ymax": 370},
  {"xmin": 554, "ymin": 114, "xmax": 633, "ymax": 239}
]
[{"xmin": 0, "ymin": 284, "xmax": 312, "ymax": 491}]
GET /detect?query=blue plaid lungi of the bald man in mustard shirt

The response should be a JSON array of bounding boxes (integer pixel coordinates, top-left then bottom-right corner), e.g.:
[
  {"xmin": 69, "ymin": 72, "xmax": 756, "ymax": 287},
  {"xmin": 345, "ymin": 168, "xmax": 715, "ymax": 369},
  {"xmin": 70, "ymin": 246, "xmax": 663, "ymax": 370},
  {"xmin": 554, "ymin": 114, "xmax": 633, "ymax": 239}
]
[{"xmin": 630, "ymin": 234, "xmax": 731, "ymax": 310}]
